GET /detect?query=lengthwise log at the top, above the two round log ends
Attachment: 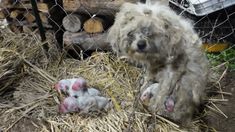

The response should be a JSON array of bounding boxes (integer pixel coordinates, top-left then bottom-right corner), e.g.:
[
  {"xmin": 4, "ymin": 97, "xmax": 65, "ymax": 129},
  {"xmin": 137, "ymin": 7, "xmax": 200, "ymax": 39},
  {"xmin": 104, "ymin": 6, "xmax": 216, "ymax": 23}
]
[{"xmin": 63, "ymin": 0, "xmax": 139, "ymax": 15}]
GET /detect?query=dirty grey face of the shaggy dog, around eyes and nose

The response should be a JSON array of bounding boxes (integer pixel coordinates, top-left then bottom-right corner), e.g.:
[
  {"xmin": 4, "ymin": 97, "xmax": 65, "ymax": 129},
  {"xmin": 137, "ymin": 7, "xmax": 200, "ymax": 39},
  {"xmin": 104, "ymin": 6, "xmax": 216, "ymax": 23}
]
[{"xmin": 117, "ymin": 16, "xmax": 168, "ymax": 60}]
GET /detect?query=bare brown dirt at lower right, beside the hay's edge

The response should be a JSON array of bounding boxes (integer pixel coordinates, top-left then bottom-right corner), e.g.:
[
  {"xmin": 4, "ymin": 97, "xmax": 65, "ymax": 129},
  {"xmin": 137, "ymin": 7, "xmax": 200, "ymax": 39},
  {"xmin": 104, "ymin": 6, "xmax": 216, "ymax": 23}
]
[{"xmin": 206, "ymin": 71, "xmax": 235, "ymax": 132}]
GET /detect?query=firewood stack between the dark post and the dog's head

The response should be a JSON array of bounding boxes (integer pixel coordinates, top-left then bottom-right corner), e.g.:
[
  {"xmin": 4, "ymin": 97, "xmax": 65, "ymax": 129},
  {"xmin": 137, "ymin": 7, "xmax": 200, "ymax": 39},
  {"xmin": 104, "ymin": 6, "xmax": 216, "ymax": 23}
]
[{"xmin": 63, "ymin": 0, "xmax": 138, "ymax": 51}]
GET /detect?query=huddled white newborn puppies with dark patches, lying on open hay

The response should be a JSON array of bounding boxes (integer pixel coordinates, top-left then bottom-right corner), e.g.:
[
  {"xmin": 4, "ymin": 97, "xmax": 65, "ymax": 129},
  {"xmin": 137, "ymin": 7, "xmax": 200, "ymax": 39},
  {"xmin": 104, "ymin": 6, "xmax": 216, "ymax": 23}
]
[{"xmin": 54, "ymin": 77, "xmax": 112, "ymax": 114}]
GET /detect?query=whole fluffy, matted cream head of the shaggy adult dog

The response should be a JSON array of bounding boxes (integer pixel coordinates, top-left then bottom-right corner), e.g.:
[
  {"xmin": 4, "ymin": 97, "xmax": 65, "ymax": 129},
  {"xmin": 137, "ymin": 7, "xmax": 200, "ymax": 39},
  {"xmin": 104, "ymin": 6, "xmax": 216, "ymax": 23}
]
[{"xmin": 108, "ymin": 4, "xmax": 193, "ymax": 61}]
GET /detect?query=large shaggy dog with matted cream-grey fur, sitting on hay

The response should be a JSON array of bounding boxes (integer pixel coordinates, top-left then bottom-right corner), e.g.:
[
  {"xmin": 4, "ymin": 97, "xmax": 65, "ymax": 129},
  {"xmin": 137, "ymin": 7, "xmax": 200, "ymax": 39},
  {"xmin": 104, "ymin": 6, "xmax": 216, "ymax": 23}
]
[{"xmin": 107, "ymin": 2, "xmax": 208, "ymax": 123}]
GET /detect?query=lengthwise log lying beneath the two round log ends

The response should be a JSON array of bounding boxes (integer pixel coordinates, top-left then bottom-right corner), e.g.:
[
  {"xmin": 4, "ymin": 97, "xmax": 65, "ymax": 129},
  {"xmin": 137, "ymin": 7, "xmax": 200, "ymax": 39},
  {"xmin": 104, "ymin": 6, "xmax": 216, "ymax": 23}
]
[{"xmin": 63, "ymin": 31, "xmax": 111, "ymax": 51}]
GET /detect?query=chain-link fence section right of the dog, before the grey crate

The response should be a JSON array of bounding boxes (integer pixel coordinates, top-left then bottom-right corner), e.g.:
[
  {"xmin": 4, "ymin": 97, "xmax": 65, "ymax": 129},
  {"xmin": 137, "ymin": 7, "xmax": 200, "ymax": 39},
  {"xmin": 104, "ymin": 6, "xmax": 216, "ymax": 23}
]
[{"xmin": 170, "ymin": 0, "xmax": 235, "ymax": 70}]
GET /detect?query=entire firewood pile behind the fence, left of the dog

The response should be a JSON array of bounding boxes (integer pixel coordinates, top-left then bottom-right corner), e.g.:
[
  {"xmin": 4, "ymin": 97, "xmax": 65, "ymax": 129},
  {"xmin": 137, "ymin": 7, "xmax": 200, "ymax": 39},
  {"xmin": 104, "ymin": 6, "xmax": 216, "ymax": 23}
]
[{"xmin": 0, "ymin": 0, "xmax": 139, "ymax": 51}]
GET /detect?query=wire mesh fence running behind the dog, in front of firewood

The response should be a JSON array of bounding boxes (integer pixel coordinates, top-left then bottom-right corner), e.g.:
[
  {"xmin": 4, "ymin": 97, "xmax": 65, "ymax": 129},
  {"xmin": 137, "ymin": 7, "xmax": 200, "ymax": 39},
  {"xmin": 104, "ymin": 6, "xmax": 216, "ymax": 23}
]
[{"xmin": 0, "ymin": 0, "xmax": 235, "ymax": 57}]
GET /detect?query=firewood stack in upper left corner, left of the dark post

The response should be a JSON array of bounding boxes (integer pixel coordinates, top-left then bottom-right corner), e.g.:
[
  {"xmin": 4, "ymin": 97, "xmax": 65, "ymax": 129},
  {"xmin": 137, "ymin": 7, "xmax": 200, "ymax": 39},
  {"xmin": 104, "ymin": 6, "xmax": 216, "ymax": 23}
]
[{"xmin": 0, "ymin": 0, "xmax": 51, "ymax": 32}]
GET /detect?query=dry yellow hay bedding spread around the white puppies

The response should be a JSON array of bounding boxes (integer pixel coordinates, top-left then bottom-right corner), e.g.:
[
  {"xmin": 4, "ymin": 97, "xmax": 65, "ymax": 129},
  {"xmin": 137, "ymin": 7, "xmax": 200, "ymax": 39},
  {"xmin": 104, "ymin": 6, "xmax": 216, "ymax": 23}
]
[{"xmin": 0, "ymin": 29, "xmax": 228, "ymax": 132}]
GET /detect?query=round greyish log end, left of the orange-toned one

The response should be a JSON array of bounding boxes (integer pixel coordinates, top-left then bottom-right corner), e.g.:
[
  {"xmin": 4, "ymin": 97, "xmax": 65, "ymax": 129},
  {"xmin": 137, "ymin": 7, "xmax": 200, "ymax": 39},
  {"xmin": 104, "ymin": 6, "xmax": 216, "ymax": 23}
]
[{"xmin": 62, "ymin": 14, "xmax": 87, "ymax": 33}]
